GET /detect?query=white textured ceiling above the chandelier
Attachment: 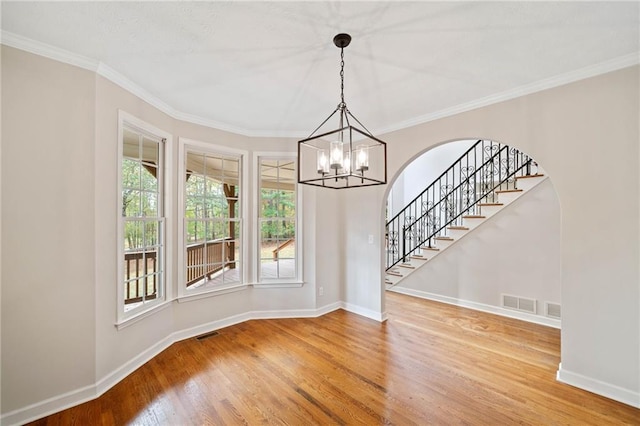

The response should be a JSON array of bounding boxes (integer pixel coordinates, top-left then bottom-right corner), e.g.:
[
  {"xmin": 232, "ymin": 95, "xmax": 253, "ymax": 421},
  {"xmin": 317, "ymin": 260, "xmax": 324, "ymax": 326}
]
[{"xmin": 2, "ymin": 2, "xmax": 640, "ymax": 136}]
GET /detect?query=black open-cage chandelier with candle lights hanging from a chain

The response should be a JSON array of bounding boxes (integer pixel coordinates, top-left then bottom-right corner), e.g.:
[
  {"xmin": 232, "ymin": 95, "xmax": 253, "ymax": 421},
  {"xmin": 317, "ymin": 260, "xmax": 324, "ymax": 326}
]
[{"xmin": 298, "ymin": 34, "xmax": 387, "ymax": 189}]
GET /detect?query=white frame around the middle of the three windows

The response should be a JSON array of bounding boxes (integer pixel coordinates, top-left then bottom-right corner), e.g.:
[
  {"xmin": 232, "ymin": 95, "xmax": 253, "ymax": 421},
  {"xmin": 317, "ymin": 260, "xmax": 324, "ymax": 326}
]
[{"xmin": 177, "ymin": 137, "xmax": 249, "ymax": 302}]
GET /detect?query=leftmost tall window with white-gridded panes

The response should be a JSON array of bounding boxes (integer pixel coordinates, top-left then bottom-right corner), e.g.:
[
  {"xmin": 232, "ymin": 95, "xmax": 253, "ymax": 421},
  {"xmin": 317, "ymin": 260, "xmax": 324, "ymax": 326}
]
[{"xmin": 118, "ymin": 113, "xmax": 170, "ymax": 320}]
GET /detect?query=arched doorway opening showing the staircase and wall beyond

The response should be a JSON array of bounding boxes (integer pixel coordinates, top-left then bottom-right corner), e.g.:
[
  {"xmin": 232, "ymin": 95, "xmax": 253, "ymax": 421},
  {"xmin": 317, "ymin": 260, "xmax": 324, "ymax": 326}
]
[{"xmin": 383, "ymin": 139, "xmax": 561, "ymax": 328}]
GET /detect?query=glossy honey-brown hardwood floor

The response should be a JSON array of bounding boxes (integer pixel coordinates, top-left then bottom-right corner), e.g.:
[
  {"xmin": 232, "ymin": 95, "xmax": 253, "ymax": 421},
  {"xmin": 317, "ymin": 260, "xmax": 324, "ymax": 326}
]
[{"xmin": 28, "ymin": 292, "xmax": 640, "ymax": 426}]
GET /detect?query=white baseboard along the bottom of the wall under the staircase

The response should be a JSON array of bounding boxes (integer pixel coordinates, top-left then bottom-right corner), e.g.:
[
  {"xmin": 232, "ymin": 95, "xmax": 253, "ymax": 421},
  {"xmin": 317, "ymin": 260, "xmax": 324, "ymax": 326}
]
[{"xmin": 387, "ymin": 286, "xmax": 561, "ymax": 329}]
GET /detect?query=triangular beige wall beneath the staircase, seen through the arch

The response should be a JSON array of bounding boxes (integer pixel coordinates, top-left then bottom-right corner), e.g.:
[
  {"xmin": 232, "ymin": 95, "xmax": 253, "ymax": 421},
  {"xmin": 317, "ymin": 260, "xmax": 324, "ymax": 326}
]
[{"xmin": 395, "ymin": 179, "xmax": 562, "ymax": 323}]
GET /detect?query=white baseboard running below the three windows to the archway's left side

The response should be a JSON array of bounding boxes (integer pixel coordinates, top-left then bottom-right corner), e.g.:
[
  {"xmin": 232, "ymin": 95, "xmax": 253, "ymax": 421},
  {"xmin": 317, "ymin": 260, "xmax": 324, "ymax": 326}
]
[{"xmin": 0, "ymin": 302, "xmax": 356, "ymax": 426}]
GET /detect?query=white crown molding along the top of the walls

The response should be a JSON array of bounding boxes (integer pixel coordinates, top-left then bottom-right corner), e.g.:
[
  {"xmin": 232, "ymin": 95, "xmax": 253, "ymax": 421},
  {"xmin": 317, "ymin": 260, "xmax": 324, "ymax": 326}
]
[{"xmin": 1, "ymin": 30, "xmax": 640, "ymax": 138}]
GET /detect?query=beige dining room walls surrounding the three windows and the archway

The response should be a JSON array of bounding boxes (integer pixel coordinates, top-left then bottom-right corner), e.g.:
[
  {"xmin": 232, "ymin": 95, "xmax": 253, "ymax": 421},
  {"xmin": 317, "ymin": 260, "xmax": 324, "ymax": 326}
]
[{"xmin": 1, "ymin": 46, "xmax": 640, "ymax": 419}]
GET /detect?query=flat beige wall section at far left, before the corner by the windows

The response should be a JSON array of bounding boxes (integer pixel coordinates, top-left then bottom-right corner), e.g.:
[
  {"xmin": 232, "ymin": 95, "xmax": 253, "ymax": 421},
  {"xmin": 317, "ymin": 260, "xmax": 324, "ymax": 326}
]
[{"xmin": 1, "ymin": 48, "xmax": 96, "ymax": 412}]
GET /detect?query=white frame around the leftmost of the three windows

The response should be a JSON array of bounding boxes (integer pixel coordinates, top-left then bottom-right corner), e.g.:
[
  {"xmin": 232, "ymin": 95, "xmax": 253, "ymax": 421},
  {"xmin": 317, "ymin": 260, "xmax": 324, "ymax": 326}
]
[{"xmin": 115, "ymin": 110, "xmax": 174, "ymax": 329}]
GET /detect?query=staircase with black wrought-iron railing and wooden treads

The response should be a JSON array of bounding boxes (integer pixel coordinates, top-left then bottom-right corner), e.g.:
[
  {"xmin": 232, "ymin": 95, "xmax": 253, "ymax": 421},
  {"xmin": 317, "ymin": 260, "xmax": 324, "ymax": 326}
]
[{"xmin": 385, "ymin": 140, "xmax": 546, "ymax": 289}]
